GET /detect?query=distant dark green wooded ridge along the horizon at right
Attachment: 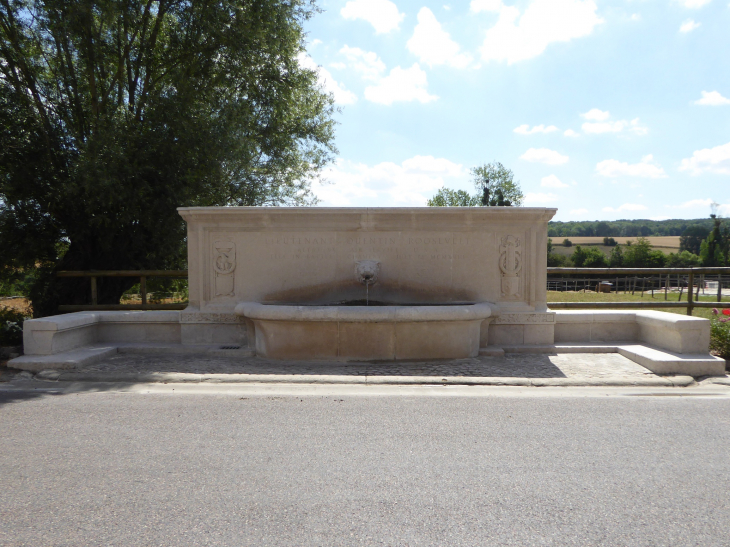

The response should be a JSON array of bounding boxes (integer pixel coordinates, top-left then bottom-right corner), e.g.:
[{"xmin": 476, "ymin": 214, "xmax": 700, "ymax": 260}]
[{"xmin": 548, "ymin": 218, "xmax": 716, "ymax": 237}]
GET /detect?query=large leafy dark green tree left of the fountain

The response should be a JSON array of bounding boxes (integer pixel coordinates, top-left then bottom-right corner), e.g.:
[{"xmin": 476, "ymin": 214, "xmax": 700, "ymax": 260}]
[{"xmin": 0, "ymin": 0, "xmax": 336, "ymax": 315}]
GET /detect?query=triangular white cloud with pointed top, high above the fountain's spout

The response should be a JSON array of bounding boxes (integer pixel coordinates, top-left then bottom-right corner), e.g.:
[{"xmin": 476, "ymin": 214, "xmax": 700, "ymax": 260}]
[{"xmin": 406, "ymin": 8, "xmax": 471, "ymax": 68}]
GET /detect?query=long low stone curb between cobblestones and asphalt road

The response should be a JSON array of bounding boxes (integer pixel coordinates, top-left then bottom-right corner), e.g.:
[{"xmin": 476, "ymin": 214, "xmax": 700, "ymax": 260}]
[{"xmin": 34, "ymin": 370, "xmax": 695, "ymax": 387}]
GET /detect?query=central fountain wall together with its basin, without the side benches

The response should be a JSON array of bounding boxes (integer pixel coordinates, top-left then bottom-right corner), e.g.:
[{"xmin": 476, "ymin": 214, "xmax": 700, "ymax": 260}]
[{"xmin": 180, "ymin": 208, "xmax": 556, "ymax": 360}]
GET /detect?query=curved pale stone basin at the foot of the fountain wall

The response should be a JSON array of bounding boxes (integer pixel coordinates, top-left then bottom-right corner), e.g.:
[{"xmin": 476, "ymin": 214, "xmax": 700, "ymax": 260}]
[{"xmin": 235, "ymin": 302, "xmax": 492, "ymax": 360}]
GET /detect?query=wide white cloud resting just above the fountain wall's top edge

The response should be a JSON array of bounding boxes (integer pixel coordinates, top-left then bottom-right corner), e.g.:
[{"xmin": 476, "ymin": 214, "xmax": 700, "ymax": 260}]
[{"xmin": 312, "ymin": 156, "xmax": 469, "ymax": 207}]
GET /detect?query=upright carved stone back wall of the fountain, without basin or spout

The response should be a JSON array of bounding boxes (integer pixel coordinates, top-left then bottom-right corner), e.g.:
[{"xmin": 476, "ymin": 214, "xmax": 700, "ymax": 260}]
[{"xmin": 179, "ymin": 207, "xmax": 556, "ymax": 347}]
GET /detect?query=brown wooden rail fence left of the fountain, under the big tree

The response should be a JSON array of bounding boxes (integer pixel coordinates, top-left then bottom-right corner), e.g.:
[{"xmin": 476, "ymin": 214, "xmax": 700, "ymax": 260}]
[{"xmin": 56, "ymin": 270, "xmax": 188, "ymax": 312}]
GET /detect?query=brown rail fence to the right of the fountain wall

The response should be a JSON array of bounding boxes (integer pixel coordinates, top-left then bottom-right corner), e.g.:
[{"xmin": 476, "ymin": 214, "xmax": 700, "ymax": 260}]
[{"xmin": 547, "ymin": 267, "xmax": 730, "ymax": 315}]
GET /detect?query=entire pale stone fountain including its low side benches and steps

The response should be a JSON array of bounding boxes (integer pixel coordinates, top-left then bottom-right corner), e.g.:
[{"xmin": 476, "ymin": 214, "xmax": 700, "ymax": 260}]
[{"xmin": 10, "ymin": 207, "xmax": 725, "ymax": 376}]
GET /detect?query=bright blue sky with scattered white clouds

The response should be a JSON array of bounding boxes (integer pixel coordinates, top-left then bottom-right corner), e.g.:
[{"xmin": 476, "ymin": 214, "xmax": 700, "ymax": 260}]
[{"xmin": 299, "ymin": 0, "xmax": 730, "ymax": 221}]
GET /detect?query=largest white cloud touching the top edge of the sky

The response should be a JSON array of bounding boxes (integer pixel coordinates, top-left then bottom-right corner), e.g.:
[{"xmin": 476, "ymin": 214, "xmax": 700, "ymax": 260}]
[{"xmin": 480, "ymin": 0, "xmax": 603, "ymax": 64}]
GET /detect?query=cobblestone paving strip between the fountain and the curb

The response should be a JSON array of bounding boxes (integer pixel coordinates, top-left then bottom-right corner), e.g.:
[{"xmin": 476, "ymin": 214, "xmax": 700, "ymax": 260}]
[{"xmin": 83, "ymin": 353, "xmax": 654, "ymax": 378}]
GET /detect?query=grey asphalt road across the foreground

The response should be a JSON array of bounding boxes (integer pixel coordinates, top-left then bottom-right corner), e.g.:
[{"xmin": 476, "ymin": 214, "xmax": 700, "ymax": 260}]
[{"xmin": 0, "ymin": 388, "xmax": 730, "ymax": 547}]
